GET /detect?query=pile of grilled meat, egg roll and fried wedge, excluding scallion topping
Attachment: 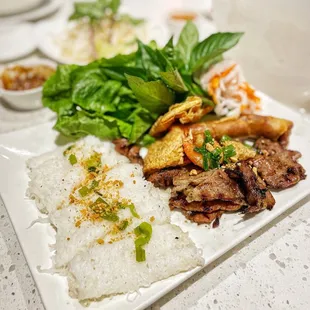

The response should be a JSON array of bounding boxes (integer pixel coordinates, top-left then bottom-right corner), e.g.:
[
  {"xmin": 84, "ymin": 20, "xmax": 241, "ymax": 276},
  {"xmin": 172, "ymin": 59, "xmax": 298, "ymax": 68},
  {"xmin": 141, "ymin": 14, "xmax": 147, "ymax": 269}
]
[{"xmin": 113, "ymin": 115, "xmax": 306, "ymax": 227}]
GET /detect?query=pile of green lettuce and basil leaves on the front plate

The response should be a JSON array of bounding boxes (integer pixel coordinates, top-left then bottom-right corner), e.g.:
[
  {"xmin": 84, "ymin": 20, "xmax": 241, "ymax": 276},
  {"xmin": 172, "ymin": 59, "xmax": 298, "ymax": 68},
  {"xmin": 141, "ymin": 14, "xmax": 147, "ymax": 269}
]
[{"xmin": 43, "ymin": 22, "xmax": 242, "ymax": 144}]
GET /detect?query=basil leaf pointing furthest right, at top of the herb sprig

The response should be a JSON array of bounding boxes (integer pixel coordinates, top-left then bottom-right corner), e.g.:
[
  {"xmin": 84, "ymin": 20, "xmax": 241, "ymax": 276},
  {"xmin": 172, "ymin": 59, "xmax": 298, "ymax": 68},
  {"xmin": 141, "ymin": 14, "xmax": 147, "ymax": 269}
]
[{"xmin": 189, "ymin": 32, "xmax": 243, "ymax": 72}]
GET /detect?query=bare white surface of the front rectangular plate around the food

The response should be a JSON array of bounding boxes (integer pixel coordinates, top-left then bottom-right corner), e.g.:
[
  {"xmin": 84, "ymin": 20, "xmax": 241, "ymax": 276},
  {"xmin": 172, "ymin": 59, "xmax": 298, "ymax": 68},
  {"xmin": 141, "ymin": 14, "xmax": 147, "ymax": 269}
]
[{"xmin": 0, "ymin": 94, "xmax": 310, "ymax": 310}]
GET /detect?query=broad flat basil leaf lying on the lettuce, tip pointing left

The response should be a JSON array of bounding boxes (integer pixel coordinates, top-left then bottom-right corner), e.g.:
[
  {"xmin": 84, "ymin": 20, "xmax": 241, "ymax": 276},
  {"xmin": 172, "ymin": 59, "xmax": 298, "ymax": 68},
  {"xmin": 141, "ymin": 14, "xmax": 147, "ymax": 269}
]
[{"xmin": 126, "ymin": 75, "xmax": 175, "ymax": 115}]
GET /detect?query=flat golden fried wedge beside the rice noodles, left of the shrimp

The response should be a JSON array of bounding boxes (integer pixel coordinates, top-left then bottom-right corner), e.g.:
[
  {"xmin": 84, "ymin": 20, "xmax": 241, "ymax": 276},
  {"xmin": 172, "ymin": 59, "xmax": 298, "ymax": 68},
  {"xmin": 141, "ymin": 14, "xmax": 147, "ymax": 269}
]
[{"xmin": 143, "ymin": 127, "xmax": 184, "ymax": 175}]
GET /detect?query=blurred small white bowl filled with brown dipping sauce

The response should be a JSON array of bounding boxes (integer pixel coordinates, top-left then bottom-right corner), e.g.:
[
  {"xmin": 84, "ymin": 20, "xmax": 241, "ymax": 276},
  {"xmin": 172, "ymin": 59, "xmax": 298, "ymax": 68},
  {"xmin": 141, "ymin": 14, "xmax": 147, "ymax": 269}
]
[{"xmin": 0, "ymin": 59, "xmax": 57, "ymax": 110}]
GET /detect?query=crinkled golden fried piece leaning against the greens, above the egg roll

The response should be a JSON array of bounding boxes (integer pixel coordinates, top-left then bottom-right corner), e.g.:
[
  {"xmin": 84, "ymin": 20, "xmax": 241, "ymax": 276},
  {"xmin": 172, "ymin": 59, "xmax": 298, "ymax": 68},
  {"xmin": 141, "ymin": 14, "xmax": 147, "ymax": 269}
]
[{"xmin": 150, "ymin": 96, "xmax": 213, "ymax": 137}]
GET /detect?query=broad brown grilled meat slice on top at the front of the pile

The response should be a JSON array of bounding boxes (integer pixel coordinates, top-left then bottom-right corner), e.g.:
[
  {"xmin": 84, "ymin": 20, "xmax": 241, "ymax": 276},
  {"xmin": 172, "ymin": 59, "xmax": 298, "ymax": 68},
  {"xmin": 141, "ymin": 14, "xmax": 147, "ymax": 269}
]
[{"xmin": 172, "ymin": 169, "xmax": 244, "ymax": 204}]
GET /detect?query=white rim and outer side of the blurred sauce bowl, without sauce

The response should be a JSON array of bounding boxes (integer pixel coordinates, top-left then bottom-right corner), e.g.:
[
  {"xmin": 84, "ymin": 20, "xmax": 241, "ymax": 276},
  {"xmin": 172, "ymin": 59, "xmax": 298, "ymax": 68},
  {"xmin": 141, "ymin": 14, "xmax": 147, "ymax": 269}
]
[{"xmin": 0, "ymin": 58, "xmax": 57, "ymax": 110}]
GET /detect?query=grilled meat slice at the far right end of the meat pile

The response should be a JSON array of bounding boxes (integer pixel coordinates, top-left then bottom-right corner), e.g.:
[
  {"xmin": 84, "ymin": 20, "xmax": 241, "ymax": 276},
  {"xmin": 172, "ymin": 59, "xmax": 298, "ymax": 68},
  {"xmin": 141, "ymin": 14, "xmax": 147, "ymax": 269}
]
[{"xmin": 251, "ymin": 149, "xmax": 306, "ymax": 190}]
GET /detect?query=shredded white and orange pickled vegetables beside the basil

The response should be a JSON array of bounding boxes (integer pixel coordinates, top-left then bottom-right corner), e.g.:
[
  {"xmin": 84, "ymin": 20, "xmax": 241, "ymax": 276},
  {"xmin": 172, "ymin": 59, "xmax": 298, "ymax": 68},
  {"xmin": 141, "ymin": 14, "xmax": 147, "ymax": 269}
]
[{"xmin": 201, "ymin": 60, "xmax": 261, "ymax": 117}]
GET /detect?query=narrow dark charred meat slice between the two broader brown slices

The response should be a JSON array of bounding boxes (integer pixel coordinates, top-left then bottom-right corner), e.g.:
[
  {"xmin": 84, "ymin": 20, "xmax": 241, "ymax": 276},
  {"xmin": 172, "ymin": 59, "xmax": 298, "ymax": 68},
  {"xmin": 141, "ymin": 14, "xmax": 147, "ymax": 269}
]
[{"xmin": 226, "ymin": 161, "xmax": 275, "ymax": 213}]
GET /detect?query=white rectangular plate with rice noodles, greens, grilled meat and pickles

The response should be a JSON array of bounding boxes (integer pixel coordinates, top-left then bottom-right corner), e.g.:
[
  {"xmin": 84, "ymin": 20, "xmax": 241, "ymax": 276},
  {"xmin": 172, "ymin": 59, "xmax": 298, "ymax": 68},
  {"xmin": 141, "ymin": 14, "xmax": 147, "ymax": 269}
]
[{"xmin": 0, "ymin": 22, "xmax": 310, "ymax": 309}]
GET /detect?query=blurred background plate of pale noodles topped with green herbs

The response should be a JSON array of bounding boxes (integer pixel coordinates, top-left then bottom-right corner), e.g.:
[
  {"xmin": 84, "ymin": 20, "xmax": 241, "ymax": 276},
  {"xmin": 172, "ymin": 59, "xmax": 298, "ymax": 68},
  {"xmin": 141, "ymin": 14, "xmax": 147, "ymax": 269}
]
[{"xmin": 36, "ymin": 0, "xmax": 167, "ymax": 64}]
